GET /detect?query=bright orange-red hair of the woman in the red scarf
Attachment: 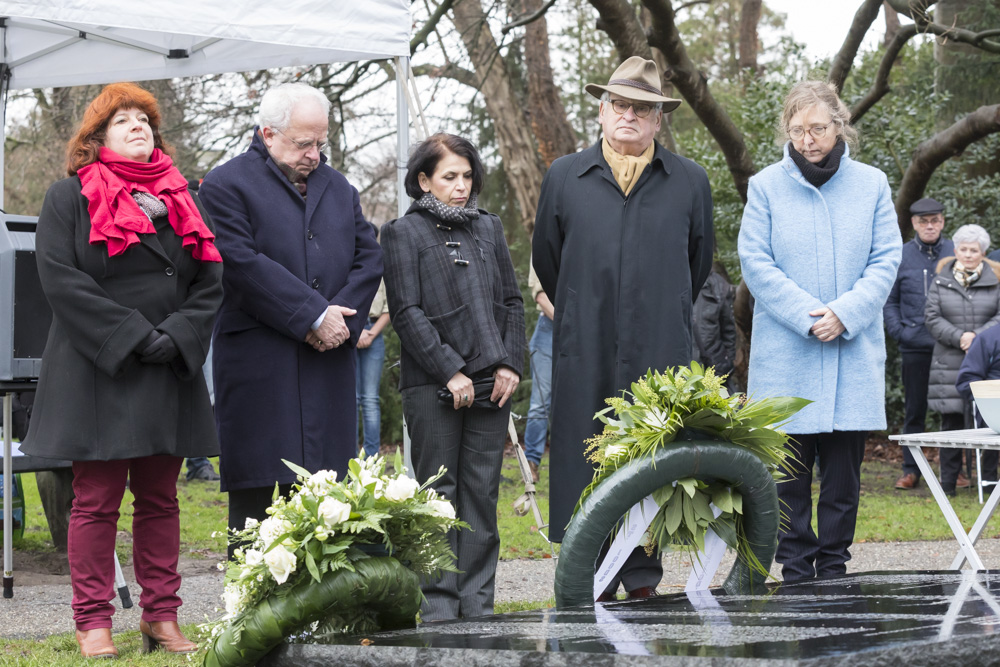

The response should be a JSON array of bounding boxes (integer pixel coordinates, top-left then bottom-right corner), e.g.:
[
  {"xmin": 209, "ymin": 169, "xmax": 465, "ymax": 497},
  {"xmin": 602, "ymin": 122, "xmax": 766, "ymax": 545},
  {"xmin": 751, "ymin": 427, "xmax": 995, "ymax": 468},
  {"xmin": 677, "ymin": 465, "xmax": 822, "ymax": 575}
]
[{"xmin": 66, "ymin": 83, "xmax": 174, "ymax": 176}]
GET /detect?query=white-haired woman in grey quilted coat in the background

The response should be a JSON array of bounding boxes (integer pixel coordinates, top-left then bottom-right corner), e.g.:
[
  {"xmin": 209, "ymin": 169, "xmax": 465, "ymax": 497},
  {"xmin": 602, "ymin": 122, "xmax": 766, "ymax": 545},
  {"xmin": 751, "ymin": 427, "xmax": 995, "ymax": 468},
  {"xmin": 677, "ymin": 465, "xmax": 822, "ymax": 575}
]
[{"xmin": 924, "ymin": 225, "xmax": 1000, "ymax": 495}]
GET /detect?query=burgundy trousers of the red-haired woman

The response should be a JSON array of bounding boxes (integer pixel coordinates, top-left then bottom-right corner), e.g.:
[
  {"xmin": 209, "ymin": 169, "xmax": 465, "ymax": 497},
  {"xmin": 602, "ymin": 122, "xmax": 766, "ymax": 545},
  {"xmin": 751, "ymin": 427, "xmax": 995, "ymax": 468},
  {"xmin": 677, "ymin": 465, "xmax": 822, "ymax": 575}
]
[{"xmin": 68, "ymin": 456, "xmax": 184, "ymax": 630}]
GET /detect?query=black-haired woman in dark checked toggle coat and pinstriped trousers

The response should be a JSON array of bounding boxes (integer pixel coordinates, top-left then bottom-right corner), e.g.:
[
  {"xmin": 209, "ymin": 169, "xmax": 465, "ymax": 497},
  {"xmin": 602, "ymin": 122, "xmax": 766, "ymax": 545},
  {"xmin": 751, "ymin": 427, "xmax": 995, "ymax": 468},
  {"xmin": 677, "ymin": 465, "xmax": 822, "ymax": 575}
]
[{"xmin": 382, "ymin": 134, "xmax": 525, "ymax": 620}]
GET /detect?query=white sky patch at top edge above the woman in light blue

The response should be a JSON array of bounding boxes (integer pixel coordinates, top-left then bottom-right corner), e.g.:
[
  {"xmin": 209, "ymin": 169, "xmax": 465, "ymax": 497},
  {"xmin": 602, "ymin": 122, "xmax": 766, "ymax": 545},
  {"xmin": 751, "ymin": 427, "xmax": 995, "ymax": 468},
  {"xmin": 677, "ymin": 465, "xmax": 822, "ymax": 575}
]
[{"xmin": 766, "ymin": 0, "xmax": 892, "ymax": 58}]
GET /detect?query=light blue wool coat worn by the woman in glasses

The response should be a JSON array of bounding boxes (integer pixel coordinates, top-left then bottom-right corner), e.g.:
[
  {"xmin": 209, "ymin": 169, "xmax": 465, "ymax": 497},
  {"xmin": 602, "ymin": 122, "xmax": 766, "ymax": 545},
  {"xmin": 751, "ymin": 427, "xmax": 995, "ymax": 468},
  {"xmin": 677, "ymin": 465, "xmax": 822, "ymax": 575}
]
[{"xmin": 739, "ymin": 144, "xmax": 902, "ymax": 433}]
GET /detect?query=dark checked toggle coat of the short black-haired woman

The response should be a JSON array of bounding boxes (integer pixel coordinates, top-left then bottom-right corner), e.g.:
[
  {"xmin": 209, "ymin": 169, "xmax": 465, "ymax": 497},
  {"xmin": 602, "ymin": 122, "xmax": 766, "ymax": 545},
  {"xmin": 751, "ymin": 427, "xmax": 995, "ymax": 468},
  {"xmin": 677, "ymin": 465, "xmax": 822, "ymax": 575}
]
[{"xmin": 382, "ymin": 206, "xmax": 525, "ymax": 390}]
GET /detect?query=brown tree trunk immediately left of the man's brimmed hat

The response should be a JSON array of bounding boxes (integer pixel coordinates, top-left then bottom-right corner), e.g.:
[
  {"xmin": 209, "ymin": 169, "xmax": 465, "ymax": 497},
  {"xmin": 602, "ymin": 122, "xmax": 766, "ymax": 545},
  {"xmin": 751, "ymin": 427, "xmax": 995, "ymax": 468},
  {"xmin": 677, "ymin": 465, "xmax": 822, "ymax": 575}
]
[{"xmin": 520, "ymin": 0, "xmax": 577, "ymax": 167}]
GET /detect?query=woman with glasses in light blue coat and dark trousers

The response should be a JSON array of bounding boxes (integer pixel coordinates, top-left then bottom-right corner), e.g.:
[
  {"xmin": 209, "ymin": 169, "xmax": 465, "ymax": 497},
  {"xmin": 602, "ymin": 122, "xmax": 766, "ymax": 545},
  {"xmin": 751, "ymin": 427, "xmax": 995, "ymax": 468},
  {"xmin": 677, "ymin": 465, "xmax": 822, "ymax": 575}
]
[{"xmin": 739, "ymin": 81, "xmax": 902, "ymax": 581}]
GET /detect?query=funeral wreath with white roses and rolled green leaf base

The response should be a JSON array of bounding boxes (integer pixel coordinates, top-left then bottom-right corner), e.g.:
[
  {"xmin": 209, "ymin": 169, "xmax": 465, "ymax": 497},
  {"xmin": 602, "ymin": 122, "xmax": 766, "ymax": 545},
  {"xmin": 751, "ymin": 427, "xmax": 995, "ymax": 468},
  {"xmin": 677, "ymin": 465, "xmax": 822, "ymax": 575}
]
[{"xmin": 204, "ymin": 454, "xmax": 467, "ymax": 667}]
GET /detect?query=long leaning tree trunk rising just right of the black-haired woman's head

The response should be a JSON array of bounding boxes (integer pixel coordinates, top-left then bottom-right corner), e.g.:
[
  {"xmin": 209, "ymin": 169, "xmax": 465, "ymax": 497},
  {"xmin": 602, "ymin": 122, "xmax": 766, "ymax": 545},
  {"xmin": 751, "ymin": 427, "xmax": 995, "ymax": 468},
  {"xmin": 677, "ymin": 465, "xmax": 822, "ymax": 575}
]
[{"xmin": 452, "ymin": 0, "xmax": 544, "ymax": 234}]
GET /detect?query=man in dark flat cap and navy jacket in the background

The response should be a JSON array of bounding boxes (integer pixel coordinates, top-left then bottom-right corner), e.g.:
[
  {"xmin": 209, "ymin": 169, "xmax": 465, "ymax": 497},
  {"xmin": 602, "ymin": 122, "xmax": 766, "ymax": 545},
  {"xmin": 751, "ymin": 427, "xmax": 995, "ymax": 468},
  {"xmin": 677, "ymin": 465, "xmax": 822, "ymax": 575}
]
[{"xmin": 882, "ymin": 197, "xmax": 952, "ymax": 490}]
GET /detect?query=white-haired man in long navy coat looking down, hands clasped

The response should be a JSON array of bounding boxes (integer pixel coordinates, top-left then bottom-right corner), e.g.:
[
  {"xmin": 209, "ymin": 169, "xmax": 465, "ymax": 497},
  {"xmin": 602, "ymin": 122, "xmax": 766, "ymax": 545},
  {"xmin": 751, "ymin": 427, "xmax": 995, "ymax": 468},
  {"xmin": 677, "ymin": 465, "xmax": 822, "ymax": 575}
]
[{"xmin": 200, "ymin": 83, "xmax": 382, "ymax": 553}]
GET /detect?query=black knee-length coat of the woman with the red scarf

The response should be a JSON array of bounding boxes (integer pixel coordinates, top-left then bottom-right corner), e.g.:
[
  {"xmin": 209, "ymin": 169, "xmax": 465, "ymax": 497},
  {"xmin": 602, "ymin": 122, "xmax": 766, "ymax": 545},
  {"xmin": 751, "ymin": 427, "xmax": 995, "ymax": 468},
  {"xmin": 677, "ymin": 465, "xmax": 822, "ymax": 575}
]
[{"xmin": 21, "ymin": 176, "xmax": 222, "ymax": 461}]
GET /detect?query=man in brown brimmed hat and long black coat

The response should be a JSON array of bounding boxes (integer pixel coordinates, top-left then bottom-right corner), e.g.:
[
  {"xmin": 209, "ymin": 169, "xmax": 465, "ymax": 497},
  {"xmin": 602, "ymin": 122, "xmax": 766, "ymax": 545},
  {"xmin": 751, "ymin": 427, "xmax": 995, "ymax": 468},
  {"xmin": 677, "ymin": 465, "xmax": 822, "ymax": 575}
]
[{"xmin": 532, "ymin": 56, "xmax": 713, "ymax": 599}]
